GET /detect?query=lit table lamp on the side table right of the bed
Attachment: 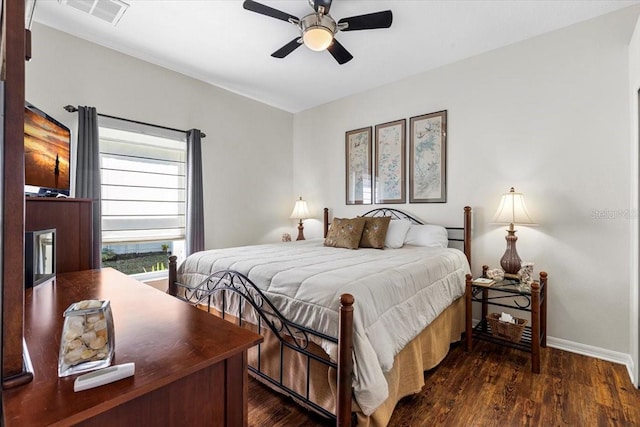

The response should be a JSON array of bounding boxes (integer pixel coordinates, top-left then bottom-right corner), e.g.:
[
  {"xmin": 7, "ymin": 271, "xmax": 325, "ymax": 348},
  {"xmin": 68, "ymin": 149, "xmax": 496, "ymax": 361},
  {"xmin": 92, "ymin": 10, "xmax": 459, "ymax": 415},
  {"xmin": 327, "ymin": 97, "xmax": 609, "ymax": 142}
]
[{"xmin": 493, "ymin": 187, "xmax": 537, "ymax": 275}]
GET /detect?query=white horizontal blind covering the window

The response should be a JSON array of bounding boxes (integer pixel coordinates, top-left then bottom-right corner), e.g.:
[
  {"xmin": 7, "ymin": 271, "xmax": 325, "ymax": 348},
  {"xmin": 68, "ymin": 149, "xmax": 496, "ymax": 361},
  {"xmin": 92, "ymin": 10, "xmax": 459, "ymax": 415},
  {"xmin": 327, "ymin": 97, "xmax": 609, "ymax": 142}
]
[{"xmin": 99, "ymin": 117, "xmax": 186, "ymax": 243}]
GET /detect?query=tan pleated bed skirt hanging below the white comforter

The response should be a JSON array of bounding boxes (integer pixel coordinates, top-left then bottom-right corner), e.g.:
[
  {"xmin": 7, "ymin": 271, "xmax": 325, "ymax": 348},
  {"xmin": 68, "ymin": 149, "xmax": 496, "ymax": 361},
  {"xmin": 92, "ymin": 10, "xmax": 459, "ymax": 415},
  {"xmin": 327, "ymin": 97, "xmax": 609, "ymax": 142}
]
[{"xmin": 198, "ymin": 298, "xmax": 465, "ymax": 426}]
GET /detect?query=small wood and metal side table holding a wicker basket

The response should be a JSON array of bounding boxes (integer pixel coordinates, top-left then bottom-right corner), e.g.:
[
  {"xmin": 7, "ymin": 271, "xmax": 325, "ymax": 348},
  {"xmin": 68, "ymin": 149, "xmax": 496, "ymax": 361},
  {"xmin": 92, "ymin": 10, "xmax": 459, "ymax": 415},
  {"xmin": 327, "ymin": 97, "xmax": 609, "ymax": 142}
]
[{"xmin": 465, "ymin": 266, "xmax": 548, "ymax": 374}]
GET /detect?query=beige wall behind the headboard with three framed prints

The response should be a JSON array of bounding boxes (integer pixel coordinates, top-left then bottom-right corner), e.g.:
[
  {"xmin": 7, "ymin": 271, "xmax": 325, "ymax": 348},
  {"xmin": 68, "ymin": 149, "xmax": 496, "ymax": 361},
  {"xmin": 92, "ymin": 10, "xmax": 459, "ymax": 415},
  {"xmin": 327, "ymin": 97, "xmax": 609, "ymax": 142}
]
[{"xmin": 293, "ymin": 7, "xmax": 639, "ymax": 372}]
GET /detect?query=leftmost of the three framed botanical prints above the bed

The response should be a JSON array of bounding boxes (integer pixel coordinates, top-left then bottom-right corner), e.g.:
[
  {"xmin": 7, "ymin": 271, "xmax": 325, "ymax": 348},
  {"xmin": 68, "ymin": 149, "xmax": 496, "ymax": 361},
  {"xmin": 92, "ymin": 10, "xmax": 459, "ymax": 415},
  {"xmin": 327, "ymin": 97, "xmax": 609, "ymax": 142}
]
[{"xmin": 345, "ymin": 127, "xmax": 372, "ymax": 205}]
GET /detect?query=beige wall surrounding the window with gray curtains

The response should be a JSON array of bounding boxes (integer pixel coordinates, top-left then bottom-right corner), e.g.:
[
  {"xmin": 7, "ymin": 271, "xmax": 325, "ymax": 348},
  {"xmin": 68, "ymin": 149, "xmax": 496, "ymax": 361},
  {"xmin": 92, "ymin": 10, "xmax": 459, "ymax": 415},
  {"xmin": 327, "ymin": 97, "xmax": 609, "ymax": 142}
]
[{"xmin": 26, "ymin": 23, "xmax": 295, "ymax": 248}]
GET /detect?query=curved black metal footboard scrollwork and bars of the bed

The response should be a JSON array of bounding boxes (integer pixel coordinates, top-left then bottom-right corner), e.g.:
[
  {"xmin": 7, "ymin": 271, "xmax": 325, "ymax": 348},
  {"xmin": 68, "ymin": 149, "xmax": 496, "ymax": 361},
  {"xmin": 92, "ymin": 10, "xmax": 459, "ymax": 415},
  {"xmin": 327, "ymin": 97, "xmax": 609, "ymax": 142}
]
[{"xmin": 173, "ymin": 270, "xmax": 340, "ymax": 420}]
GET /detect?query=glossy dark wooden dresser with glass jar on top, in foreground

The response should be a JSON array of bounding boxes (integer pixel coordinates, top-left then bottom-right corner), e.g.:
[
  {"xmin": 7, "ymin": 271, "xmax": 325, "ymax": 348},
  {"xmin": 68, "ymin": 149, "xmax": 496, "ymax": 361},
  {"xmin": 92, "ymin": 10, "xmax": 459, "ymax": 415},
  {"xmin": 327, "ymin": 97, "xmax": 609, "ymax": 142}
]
[{"xmin": 2, "ymin": 268, "xmax": 262, "ymax": 427}]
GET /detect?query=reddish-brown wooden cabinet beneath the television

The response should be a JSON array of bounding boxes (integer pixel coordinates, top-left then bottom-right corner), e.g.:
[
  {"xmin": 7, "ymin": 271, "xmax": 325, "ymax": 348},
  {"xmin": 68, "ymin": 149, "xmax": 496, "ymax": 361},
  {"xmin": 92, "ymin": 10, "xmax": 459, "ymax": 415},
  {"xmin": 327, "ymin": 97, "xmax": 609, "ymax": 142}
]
[{"xmin": 25, "ymin": 197, "xmax": 94, "ymax": 273}]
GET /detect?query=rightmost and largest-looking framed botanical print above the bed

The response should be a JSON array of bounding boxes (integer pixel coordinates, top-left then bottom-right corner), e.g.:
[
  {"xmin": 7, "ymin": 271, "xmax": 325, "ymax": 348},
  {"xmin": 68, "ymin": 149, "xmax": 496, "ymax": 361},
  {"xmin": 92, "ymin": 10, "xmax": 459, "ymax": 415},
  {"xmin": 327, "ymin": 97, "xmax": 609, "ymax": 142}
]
[{"xmin": 409, "ymin": 110, "xmax": 447, "ymax": 203}]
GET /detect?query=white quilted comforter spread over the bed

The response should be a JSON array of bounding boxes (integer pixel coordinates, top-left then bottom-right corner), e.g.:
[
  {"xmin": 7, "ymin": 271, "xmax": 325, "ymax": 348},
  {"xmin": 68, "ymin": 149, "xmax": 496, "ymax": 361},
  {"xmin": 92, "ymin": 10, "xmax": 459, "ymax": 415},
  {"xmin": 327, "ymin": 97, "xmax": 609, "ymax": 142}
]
[{"xmin": 178, "ymin": 239, "xmax": 469, "ymax": 415}]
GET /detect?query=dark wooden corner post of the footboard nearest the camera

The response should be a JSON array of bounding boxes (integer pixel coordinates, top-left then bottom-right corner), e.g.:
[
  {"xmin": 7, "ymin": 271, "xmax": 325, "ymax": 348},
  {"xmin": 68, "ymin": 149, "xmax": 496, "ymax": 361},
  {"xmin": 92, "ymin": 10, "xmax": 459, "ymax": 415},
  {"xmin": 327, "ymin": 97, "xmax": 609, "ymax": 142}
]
[{"xmin": 336, "ymin": 294, "xmax": 354, "ymax": 427}]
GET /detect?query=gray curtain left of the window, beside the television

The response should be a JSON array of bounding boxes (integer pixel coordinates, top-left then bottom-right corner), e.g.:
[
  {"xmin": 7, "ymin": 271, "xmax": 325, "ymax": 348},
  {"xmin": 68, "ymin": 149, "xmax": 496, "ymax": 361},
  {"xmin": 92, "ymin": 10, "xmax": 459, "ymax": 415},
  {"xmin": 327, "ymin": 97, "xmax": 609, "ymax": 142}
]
[{"xmin": 76, "ymin": 107, "xmax": 102, "ymax": 268}]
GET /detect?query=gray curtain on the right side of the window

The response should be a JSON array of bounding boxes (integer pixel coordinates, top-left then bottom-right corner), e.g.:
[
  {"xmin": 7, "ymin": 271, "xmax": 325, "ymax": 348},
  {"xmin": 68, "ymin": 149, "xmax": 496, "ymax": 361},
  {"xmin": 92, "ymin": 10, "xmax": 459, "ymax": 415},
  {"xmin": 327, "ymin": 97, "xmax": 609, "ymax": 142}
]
[{"xmin": 186, "ymin": 129, "xmax": 204, "ymax": 255}]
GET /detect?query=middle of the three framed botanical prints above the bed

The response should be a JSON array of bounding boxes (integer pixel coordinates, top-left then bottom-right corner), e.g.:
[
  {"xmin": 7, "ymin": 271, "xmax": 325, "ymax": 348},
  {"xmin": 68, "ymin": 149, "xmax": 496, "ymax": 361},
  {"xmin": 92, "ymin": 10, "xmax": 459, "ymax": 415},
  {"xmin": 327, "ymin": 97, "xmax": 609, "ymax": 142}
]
[{"xmin": 374, "ymin": 119, "xmax": 407, "ymax": 203}]
